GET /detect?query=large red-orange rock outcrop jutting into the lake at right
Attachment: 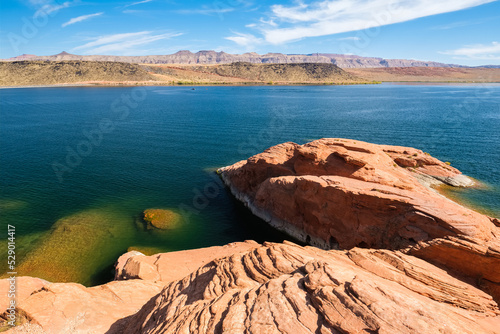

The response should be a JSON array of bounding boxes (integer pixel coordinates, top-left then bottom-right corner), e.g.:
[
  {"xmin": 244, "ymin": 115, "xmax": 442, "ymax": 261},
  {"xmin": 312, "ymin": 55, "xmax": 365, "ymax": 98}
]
[{"xmin": 219, "ymin": 139, "xmax": 500, "ymax": 299}]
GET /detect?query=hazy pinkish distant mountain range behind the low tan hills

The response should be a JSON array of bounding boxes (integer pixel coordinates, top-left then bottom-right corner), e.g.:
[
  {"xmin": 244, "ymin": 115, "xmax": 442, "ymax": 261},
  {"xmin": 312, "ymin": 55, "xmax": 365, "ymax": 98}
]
[{"xmin": 4, "ymin": 51, "xmax": 500, "ymax": 68}]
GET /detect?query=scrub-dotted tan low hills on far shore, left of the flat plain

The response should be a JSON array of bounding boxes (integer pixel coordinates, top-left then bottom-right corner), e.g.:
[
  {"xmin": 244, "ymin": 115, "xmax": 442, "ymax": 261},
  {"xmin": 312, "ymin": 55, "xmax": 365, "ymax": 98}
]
[{"xmin": 0, "ymin": 61, "xmax": 367, "ymax": 87}]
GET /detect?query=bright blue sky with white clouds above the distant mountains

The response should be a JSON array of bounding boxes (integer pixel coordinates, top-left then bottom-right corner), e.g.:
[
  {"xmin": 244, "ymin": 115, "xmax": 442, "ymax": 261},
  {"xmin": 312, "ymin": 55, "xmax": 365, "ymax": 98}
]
[{"xmin": 0, "ymin": 0, "xmax": 500, "ymax": 66}]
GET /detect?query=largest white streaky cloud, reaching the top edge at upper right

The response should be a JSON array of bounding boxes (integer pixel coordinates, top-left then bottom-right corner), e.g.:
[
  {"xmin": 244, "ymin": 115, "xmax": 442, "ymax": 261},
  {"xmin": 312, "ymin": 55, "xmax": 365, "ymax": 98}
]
[{"xmin": 260, "ymin": 0, "xmax": 496, "ymax": 44}]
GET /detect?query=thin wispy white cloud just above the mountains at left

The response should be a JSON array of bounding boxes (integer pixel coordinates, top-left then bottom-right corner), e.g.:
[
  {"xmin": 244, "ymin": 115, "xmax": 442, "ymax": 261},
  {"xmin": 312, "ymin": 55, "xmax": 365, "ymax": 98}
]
[{"xmin": 71, "ymin": 31, "xmax": 182, "ymax": 55}]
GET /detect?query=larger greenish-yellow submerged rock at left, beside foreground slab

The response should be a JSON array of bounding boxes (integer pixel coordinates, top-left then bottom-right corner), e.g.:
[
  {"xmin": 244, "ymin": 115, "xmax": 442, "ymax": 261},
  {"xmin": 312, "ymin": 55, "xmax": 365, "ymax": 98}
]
[{"xmin": 11, "ymin": 208, "xmax": 134, "ymax": 285}]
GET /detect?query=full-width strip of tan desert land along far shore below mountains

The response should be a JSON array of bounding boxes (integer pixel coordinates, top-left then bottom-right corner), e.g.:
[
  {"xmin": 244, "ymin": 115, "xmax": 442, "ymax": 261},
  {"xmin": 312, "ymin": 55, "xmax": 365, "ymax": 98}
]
[{"xmin": 0, "ymin": 60, "xmax": 500, "ymax": 87}]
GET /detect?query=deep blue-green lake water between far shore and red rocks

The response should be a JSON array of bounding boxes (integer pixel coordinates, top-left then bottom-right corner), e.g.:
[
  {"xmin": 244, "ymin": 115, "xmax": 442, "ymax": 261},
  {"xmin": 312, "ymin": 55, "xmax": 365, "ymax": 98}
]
[{"xmin": 0, "ymin": 84, "xmax": 500, "ymax": 284}]
